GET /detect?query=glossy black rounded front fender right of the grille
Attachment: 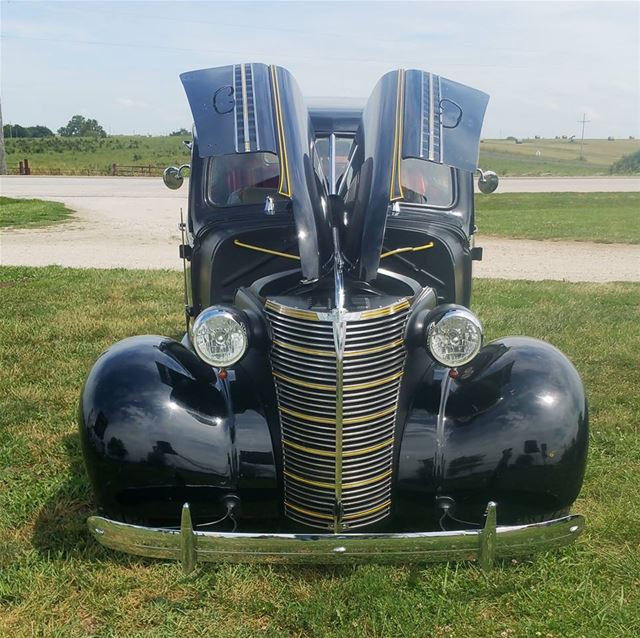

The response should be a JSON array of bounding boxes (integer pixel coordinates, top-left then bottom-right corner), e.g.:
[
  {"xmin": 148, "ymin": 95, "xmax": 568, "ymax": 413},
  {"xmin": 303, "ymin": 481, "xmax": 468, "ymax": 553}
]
[{"xmin": 396, "ymin": 337, "xmax": 588, "ymax": 524}]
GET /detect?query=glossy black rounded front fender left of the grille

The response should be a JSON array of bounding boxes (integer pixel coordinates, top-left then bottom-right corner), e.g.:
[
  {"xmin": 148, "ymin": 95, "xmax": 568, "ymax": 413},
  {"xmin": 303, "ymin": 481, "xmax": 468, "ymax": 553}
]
[{"xmin": 79, "ymin": 336, "xmax": 279, "ymax": 522}]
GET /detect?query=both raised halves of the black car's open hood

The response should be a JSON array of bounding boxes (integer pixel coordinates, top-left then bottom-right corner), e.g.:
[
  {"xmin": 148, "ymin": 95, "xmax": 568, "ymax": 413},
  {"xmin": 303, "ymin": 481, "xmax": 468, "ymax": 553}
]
[{"xmin": 180, "ymin": 64, "xmax": 488, "ymax": 281}]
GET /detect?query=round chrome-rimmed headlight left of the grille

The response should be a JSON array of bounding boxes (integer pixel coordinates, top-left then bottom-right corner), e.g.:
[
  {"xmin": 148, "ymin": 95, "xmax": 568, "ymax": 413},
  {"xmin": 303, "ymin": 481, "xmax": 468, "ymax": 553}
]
[{"xmin": 191, "ymin": 306, "xmax": 249, "ymax": 368}]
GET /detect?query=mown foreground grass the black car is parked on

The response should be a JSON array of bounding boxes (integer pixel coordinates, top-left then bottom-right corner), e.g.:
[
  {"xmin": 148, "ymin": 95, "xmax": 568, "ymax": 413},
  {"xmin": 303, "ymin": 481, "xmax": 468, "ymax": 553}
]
[{"xmin": 0, "ymin": 267, "xmax": 640, "ymax": 638}]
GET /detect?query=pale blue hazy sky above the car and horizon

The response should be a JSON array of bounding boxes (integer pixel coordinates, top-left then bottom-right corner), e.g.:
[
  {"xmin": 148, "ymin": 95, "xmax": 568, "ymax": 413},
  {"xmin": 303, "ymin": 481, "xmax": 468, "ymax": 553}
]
[{"xmin": 0, "ymin": 0, "xmax": 640, "ymax": 137}]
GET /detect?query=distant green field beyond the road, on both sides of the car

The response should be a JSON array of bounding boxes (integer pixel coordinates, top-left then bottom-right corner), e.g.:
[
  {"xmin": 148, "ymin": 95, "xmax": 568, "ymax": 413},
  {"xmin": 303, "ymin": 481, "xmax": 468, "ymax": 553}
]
[{"xmin": 6, "ymin": 135, "xmax": 640, "ymax": 176}]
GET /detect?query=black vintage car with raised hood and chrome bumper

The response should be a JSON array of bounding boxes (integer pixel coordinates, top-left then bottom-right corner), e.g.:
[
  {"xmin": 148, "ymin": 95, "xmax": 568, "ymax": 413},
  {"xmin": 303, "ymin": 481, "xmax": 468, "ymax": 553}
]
[{"xmin": 79, "ymin": 64, "xmax": 588, "ymax": 570}]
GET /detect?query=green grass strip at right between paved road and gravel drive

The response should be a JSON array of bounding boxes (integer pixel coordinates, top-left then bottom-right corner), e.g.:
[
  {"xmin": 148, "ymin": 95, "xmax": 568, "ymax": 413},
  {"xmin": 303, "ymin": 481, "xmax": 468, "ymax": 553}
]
[{"xmin": 475, "ymin": 193, "xmax": 640, "ymax": 244}]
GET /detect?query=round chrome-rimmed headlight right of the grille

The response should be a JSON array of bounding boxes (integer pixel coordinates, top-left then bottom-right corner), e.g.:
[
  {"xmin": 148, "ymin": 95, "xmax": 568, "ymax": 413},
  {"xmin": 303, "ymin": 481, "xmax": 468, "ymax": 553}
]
[{"xmin": 427, "ymin": 308, "xmax": 482, "ymax": 368}]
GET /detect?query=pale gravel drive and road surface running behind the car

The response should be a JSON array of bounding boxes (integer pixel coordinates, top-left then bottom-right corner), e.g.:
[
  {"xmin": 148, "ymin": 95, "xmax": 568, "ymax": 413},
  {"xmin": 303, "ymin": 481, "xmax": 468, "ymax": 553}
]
[{"xmin": 0, "ymin": 177, "xmax": 640, "ymax": 282}]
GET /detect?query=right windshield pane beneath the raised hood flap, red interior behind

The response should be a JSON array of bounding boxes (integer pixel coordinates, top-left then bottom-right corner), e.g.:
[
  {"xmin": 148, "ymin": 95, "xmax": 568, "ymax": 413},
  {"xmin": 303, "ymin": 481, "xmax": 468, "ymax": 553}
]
[{"xmin": 400, "ymin": 157, "xmax": 453, "ymax": 208}]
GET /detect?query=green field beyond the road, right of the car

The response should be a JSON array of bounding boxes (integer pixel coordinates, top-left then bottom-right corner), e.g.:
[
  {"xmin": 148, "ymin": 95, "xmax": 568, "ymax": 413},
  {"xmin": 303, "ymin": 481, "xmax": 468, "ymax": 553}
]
[{"xmin": 480, "ymin": 139, "xmax": 640, "ymax": 177}]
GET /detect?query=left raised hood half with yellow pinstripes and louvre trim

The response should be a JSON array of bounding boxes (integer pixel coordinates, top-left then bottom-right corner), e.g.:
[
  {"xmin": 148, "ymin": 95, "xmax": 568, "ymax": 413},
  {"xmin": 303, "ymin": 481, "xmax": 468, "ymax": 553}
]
[{"xmin": 180, "ymin": 64, "xmax": 333, "ymax": 280}]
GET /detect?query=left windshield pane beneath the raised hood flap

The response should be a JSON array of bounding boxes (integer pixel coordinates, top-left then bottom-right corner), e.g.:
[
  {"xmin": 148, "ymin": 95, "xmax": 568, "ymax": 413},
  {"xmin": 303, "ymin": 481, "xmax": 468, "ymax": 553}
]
[{"xmin": 207, "ymin": 153, "xmax": 286, "ymax": 206}]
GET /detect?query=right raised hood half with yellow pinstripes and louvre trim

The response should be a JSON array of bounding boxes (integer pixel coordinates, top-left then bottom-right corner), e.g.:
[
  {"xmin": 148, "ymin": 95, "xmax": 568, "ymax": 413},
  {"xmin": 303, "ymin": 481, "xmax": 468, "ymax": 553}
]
[{"xmin": 346, "ymin": 70, "xmax": 489, "ymax": 281}]
